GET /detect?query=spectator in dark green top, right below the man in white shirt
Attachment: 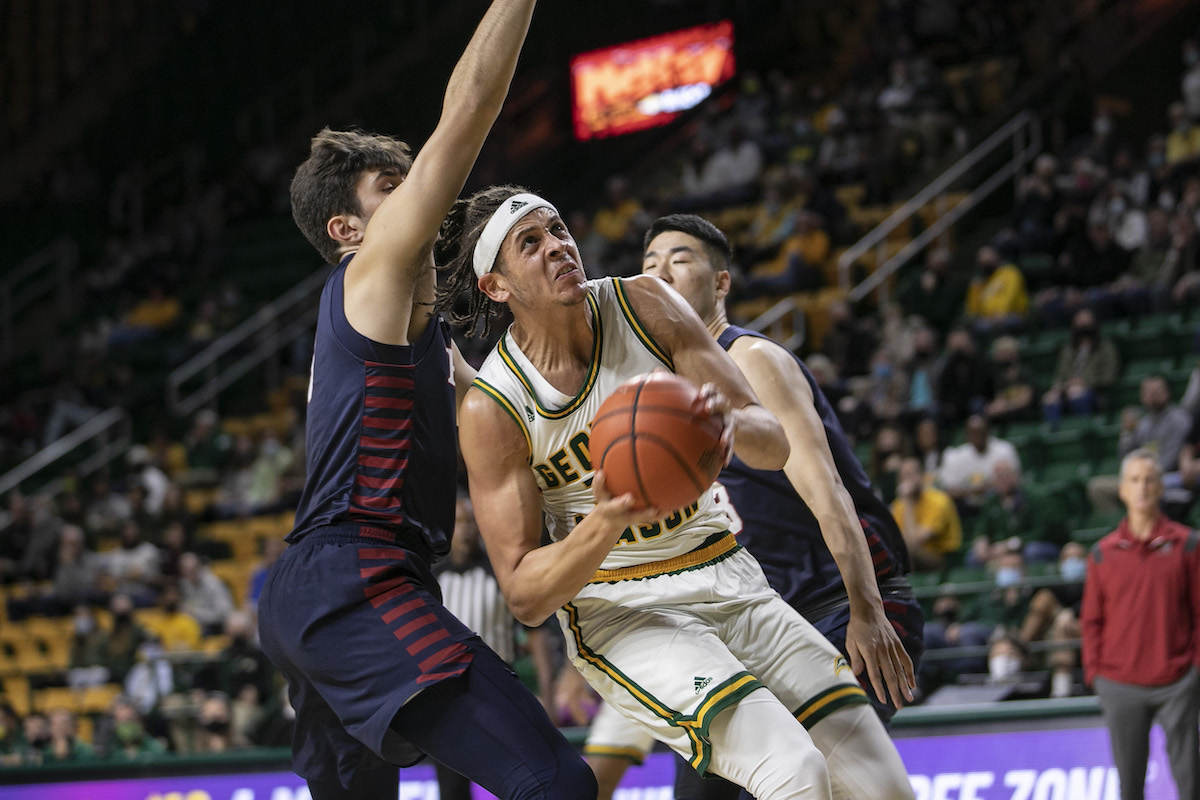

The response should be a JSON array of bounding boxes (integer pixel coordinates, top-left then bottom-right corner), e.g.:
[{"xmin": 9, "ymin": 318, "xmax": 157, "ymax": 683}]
[{"xmin": 976, "ymin": 458, "xmax": 1067, "ymax": 564}]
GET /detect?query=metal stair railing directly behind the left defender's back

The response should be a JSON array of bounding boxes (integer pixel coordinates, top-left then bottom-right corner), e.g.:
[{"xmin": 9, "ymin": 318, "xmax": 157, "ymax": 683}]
[{"xmin": 167, "ymin": 269, "xmax": 329, "ymax": 416}]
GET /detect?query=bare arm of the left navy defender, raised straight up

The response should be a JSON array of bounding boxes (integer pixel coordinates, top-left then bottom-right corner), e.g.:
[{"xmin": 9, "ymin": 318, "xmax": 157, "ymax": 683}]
[{"xmin": 346, "ymin": 0, "xmax": 535, "ymax": 342}]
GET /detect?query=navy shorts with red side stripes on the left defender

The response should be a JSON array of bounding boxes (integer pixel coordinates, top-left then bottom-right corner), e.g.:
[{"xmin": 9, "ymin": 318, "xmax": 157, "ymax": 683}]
[{"xmin": 258, "ymin": 529, "xmax": 477, "ymax": 786}]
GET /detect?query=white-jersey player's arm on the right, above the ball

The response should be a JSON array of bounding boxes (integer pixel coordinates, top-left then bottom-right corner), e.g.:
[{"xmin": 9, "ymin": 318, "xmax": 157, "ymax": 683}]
[{"xmin": 623, "ymin": 276, "xmax": 790, "ymax": 469}]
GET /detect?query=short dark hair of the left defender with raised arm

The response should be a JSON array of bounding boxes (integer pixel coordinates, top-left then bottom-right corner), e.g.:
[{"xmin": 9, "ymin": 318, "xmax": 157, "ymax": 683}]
[{"xmin": 292, "ymin": 128, "xmax": 413, "ymax": 264}]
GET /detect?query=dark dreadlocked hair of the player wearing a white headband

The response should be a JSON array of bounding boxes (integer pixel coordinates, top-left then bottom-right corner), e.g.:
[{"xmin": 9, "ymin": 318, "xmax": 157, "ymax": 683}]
[{"xmin": 433, "ymin": 184, "xmax": 529, "ymax": 338}]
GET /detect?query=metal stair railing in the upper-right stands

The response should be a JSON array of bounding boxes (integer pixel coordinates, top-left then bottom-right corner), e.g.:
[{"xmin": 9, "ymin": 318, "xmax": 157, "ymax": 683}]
[{"xmin": 838, "ymin": 110, "xmax": 1042, "ymax": 302}]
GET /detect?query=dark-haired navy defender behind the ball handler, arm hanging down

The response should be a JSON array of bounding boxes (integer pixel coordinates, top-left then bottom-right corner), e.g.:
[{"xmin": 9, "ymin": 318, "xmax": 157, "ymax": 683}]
[{"xmin": 643, "ymin": 215, "xmax": 924, "ymax": 800}]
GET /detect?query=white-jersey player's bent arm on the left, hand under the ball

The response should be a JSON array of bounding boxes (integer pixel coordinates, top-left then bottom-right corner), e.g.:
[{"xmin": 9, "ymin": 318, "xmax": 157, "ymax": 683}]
[{"xmin": 458, "ymin": 389, "xmax": 664, "ymax": 626}]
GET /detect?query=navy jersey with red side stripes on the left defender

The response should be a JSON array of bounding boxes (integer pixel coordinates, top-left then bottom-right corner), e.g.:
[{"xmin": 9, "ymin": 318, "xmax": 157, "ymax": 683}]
[{"xmin": 288, "ymin": 254, "xmax": 458, "ymax": 555}]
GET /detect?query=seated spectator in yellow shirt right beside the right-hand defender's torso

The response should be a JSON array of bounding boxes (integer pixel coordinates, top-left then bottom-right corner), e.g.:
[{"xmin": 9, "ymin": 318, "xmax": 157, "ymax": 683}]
[{"xmin": 892, "ymin": 457, "xmax": 962, "ymax": 570}]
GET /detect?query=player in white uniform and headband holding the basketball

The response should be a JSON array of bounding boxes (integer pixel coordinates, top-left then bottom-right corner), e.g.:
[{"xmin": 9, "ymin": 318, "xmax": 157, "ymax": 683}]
[{"xmin": 436, "ymin": 187, "xmax": 912, "ymax": 800}]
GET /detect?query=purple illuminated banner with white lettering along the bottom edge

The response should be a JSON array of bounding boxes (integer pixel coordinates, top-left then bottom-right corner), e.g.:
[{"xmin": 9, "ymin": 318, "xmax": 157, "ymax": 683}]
[{"xmin": 0, "ymin": 727, "xmax": 1177, "ymax": 800}]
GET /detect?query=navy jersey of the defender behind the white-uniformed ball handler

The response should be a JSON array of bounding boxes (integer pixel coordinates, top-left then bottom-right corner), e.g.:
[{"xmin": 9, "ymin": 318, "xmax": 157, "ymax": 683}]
[{"xmin": 716, "ymin": 325, "xmax": 908, "ymax": 613}]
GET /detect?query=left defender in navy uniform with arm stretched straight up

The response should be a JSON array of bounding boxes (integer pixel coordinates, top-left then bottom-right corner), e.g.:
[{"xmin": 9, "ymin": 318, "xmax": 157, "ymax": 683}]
[{"xmin": 258, "ymin": 0, "xmax": 595, "ymax": 800}]
